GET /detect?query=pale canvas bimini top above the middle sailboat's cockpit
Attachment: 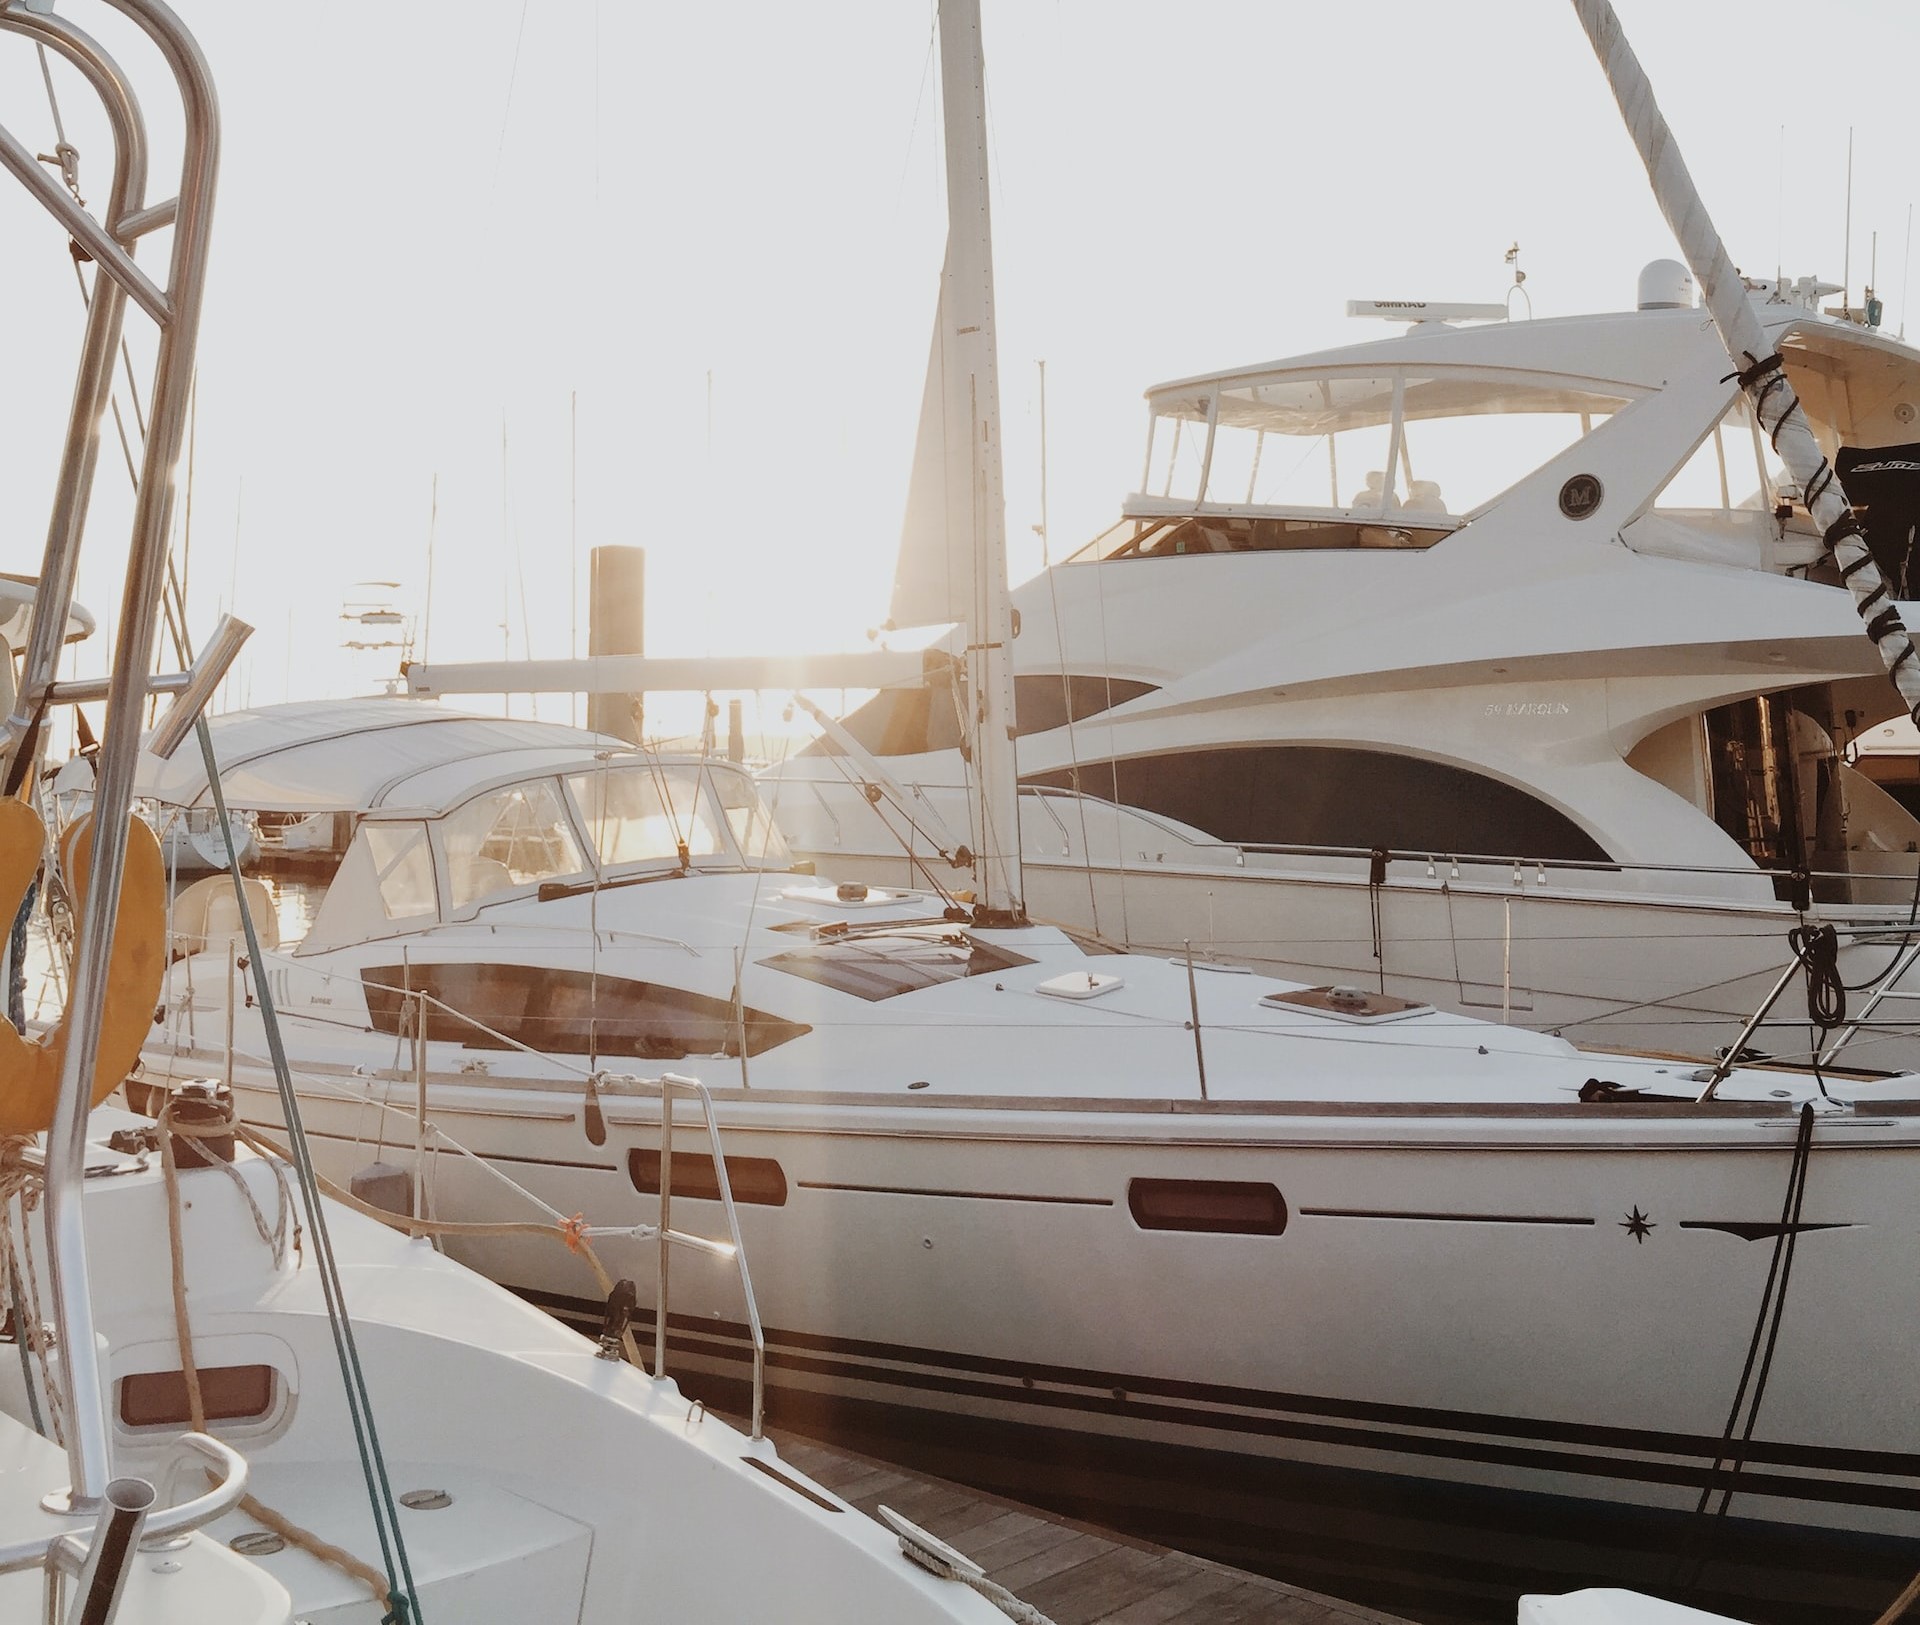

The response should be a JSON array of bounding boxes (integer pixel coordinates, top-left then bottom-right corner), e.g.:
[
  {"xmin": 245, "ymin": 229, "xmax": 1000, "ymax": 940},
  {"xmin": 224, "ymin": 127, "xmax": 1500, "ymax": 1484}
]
[{"xmin": 134, "ymin": 699, "xmax": 632, "ymax": 813}]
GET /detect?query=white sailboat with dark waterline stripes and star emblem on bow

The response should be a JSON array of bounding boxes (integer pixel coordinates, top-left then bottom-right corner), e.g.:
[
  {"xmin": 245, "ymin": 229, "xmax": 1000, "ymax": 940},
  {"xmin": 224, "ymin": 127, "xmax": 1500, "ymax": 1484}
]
[{"xmin": 146, "ymin": 8, "xmax": 1920, "ymax": 1613}]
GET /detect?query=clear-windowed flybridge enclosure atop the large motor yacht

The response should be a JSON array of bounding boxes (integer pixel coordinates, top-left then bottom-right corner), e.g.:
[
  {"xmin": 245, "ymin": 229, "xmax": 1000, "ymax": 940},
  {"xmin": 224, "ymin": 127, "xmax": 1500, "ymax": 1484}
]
[{"xmin": 1077, "ymin": 365, "xmax": 1644, "ymax": 561}]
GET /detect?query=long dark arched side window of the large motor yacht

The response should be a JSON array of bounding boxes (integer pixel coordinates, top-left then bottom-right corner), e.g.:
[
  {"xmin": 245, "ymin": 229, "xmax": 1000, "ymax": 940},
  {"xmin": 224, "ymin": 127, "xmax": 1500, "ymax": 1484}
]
[{"xmin": 1025, "ymin": 745, "xmax": 1607, "ymax": 862}]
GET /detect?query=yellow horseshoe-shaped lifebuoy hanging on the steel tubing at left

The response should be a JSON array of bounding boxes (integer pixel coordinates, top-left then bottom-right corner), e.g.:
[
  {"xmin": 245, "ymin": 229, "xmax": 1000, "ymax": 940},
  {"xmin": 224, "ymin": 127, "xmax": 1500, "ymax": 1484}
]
[{"xmin": 0, "ymin": 797, "xmax": 167, "ymax": 1135}]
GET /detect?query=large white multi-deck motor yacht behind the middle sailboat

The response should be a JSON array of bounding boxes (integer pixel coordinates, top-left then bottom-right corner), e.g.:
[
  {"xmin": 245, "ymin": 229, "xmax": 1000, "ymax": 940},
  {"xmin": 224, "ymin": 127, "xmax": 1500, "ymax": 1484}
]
[{"xmin": 774, "ymin": 261, "xmax": 1920, "ymax": 1066}]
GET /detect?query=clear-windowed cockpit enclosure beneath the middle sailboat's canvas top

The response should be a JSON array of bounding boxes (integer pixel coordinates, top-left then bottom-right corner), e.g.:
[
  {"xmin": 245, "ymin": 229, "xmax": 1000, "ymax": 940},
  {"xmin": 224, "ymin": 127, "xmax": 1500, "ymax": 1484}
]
[{"xmin": 301, "ymin": 755, "xmax": 793, "ymax": 951}]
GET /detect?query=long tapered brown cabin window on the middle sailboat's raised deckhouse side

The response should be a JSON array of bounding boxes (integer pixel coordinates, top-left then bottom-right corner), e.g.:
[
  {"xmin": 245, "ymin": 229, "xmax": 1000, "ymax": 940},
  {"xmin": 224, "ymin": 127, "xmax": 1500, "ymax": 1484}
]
[{"xmin": 361, "ymin": 962, "xmax": 810, "ymax": 1060}]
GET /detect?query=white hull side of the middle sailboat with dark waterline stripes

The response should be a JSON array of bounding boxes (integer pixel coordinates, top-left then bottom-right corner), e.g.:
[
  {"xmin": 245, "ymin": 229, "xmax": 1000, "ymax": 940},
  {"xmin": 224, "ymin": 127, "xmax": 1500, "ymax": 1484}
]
[{"xmin": 150, "ymin": 1056, "xmax": 1920, "ymax": 1535}]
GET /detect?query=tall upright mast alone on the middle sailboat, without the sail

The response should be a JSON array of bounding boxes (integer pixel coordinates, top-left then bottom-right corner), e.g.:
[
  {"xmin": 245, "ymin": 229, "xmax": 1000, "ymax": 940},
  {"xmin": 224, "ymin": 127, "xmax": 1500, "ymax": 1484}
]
[{"xmin": 939, "ymin": 0, "xmax": 1025, "ymax": 920}]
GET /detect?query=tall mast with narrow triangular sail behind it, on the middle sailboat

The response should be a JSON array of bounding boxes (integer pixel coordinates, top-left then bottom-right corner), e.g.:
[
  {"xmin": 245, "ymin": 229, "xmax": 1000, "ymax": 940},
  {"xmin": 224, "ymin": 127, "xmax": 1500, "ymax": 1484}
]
[{"xmin": 891, "ymin": 0, "xmax": 1025, "ymax": 920}]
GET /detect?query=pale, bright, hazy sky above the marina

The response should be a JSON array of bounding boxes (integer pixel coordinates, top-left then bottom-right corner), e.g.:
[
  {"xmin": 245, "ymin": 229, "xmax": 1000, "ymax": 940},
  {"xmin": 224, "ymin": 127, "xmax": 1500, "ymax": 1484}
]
[{"xmin": 0, "ymin": 0, "xmax": 1920, "ymax": 741}]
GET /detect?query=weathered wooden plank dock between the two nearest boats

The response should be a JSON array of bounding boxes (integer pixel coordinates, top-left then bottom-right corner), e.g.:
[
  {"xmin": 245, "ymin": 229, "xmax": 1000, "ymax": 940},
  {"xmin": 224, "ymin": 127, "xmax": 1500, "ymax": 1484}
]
[{"xmin": 770, "ymin": 1429, "xmax": 1405, "ymax": 1625}]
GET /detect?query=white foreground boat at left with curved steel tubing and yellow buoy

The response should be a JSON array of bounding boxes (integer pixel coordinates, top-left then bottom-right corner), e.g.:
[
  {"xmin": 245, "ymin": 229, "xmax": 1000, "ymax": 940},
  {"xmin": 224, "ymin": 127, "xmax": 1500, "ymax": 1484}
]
[{"xmin": 0, "ymin": 0, "xmax": 1002, "ymax": 1625}]
